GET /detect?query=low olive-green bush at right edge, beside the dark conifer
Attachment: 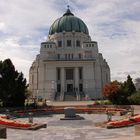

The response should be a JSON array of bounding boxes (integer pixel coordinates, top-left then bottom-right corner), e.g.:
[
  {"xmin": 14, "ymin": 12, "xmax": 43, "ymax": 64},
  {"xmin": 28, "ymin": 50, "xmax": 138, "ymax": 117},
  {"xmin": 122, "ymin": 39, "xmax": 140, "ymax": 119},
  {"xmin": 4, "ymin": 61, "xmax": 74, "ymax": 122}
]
[{"xmin": 128, "ymin": 90, "xmax": 140, "ymax": 105}]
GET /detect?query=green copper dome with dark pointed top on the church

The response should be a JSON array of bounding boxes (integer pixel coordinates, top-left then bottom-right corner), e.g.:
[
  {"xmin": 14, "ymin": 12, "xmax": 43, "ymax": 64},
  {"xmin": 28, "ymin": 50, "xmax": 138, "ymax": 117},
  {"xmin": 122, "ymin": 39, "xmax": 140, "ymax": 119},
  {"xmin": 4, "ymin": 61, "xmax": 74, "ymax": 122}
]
[{"xmin": 49, "ymin": 9, "xmax": 89, "ymax": 35}]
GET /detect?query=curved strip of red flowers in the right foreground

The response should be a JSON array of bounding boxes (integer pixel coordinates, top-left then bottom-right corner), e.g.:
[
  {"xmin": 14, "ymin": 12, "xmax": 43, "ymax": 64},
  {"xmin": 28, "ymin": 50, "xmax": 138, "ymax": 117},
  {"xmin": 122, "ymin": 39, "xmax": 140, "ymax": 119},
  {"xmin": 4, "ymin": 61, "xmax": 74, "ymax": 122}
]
[{"xmin": 107, "ymin": 114, "xmax": 140, "ymax": 128}]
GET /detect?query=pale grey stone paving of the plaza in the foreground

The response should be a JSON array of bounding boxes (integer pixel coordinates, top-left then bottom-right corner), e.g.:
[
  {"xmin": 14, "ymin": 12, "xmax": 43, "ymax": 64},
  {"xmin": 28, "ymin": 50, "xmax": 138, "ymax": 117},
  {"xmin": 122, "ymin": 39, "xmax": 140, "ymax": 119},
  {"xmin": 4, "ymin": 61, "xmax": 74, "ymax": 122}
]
[{"xmin": 4, "ymin": 114, "xmax": 139, "ymax": 140}]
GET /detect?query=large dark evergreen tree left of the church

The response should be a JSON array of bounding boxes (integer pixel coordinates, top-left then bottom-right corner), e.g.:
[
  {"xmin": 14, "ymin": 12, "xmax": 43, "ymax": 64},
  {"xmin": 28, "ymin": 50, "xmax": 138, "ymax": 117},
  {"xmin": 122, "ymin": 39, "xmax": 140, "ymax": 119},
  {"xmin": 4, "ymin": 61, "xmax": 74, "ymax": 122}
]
[{"xmin": 0, "ymin": 59, "xmax": 27, "ymax": 106}]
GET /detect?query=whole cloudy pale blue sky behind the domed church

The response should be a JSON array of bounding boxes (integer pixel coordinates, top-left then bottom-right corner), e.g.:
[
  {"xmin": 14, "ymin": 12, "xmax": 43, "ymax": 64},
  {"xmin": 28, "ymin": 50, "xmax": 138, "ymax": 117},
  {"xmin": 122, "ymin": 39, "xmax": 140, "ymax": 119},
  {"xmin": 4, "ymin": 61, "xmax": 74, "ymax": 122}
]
[{"xmin": 0, "ymin": 0, "xmax": 140, "ymax": 81}]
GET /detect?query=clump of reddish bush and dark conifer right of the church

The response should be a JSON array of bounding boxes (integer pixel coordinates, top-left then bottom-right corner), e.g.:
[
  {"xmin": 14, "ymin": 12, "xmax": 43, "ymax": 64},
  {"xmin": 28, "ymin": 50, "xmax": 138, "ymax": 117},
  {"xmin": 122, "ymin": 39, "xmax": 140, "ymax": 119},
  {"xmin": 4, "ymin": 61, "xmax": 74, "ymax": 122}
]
[{"xmin": 103, "ymin": 75, "xmax": 136, "ymax": 105}]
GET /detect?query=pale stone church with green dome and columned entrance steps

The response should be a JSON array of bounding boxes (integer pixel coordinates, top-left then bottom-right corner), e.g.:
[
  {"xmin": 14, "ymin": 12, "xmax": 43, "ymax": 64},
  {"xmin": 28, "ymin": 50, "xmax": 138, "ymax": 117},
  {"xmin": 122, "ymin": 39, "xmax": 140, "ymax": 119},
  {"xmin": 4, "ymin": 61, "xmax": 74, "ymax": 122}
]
[{"xmin": 29, "ymin": 8, "xmax": 110, "ymax": 101}]
